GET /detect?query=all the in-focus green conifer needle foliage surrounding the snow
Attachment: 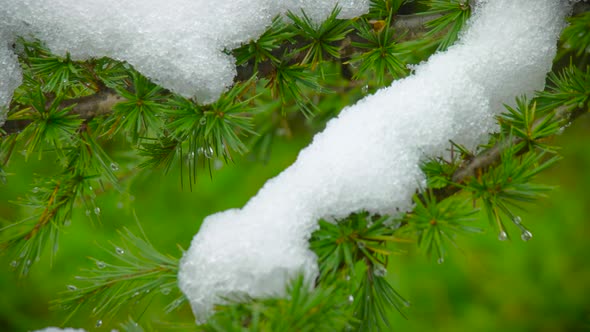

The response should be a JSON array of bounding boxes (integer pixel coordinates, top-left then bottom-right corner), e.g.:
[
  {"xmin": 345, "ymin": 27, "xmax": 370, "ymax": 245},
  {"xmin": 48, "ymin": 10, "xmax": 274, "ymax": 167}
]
[{"xmin": 0, "ymin": 0, "xmax": 590, "ymax": 331}]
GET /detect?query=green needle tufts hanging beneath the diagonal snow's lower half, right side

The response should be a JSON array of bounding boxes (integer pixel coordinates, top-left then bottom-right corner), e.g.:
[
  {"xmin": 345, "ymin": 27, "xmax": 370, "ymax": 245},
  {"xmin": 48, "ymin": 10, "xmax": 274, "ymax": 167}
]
[{"xmin": 310, "ymin": 213, "xmax": 408, "ymax": 331}]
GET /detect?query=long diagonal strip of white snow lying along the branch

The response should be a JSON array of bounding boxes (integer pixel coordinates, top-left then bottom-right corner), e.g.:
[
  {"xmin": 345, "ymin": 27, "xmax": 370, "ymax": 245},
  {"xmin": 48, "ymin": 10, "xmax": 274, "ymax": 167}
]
[{"xmin": 179, "ymin": 0, "xmax": 569, "ymax": 322}]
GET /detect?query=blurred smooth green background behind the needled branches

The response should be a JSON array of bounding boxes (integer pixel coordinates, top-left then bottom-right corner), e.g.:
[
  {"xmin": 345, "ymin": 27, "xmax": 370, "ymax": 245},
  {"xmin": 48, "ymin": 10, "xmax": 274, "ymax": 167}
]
[{"xmin": 0, "ymin": 116, "xmax": 590, "ymax": 331}]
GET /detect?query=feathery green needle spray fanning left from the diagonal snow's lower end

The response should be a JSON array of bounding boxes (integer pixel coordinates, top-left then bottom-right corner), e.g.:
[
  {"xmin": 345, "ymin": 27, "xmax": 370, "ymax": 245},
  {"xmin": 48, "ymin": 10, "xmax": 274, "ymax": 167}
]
[{"xmin": 53, "ymin": 228, "xmax": 186, "ymax": 327}]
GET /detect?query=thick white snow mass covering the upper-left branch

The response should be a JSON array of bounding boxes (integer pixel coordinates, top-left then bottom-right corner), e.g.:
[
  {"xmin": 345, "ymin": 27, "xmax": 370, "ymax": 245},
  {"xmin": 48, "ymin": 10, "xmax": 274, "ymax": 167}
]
[{"xmin": 0, "ymin": 0, "xmax": 369, "ymax": 109}]
